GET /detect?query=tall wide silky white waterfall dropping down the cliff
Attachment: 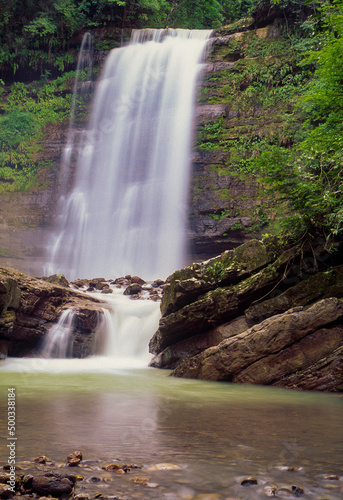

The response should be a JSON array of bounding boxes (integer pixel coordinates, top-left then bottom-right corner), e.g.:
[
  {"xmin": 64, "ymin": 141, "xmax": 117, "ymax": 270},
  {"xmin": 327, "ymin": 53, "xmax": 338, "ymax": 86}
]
[{"xmin": 46, "ymin": 29, "xmax": 211, "ymax": 280}]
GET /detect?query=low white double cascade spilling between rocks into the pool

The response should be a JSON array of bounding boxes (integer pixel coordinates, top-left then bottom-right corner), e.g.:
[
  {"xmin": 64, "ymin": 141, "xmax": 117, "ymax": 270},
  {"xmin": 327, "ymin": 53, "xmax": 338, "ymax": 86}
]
[{"xmin": 40, "ymin": 288, "xmax": 160, "ymax": 368}]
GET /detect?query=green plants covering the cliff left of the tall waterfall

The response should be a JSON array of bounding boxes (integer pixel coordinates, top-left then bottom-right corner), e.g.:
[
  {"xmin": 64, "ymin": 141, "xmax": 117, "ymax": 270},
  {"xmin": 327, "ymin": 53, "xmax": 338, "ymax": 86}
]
[{"xmin": 0, "ymin": 72, "xmax": 75, "ymax": 191}]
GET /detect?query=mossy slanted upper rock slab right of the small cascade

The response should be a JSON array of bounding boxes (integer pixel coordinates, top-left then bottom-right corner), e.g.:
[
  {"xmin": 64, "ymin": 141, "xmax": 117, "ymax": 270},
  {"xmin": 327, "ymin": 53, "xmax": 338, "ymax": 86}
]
[{"xmin": 149, "ymin": 244, "xmax": 296, "ymax": 354}]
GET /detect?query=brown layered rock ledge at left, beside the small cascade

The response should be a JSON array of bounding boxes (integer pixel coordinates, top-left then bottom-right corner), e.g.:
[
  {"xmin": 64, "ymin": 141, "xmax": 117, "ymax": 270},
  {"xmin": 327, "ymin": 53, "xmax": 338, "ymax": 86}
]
[{"xmin": 0, "ymin": 267, "xmax": 106, "ymax": 358}]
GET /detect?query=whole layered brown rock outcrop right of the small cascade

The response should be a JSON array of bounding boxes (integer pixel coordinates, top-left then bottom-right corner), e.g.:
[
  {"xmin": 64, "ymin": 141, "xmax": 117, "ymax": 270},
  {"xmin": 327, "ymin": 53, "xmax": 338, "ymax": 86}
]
[{"xmin": 150, "ymin": 240, "xmax": 343, "ymax": 391}]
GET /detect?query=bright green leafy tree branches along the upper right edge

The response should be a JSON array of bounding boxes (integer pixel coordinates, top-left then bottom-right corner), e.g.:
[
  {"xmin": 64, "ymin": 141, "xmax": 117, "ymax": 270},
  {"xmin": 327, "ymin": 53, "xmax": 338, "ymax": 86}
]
[{"xmin": 257, "ymin": 0, "xmax": 343, "ymax": 240}]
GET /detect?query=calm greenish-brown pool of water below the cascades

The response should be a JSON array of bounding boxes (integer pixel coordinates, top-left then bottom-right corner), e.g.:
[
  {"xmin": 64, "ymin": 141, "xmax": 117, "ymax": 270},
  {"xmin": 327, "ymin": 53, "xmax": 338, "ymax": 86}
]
[{"xmin": 0, "ymin": 358, "xmax": 343, "ymax": 500}]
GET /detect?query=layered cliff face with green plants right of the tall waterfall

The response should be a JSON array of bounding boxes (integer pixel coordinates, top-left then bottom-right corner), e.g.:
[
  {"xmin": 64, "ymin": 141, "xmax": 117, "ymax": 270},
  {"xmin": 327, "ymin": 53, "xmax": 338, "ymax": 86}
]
[{"xmin": 189, "ymin": 16, "xmax": 306, "ymax": 259}]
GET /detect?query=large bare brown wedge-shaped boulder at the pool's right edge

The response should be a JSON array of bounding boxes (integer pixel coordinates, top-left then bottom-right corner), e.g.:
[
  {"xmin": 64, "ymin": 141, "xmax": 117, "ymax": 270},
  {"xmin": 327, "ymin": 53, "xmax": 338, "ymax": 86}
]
[{"xmin": 173, "ymin": 298, "xmax": 343, "ymax": 391}]
